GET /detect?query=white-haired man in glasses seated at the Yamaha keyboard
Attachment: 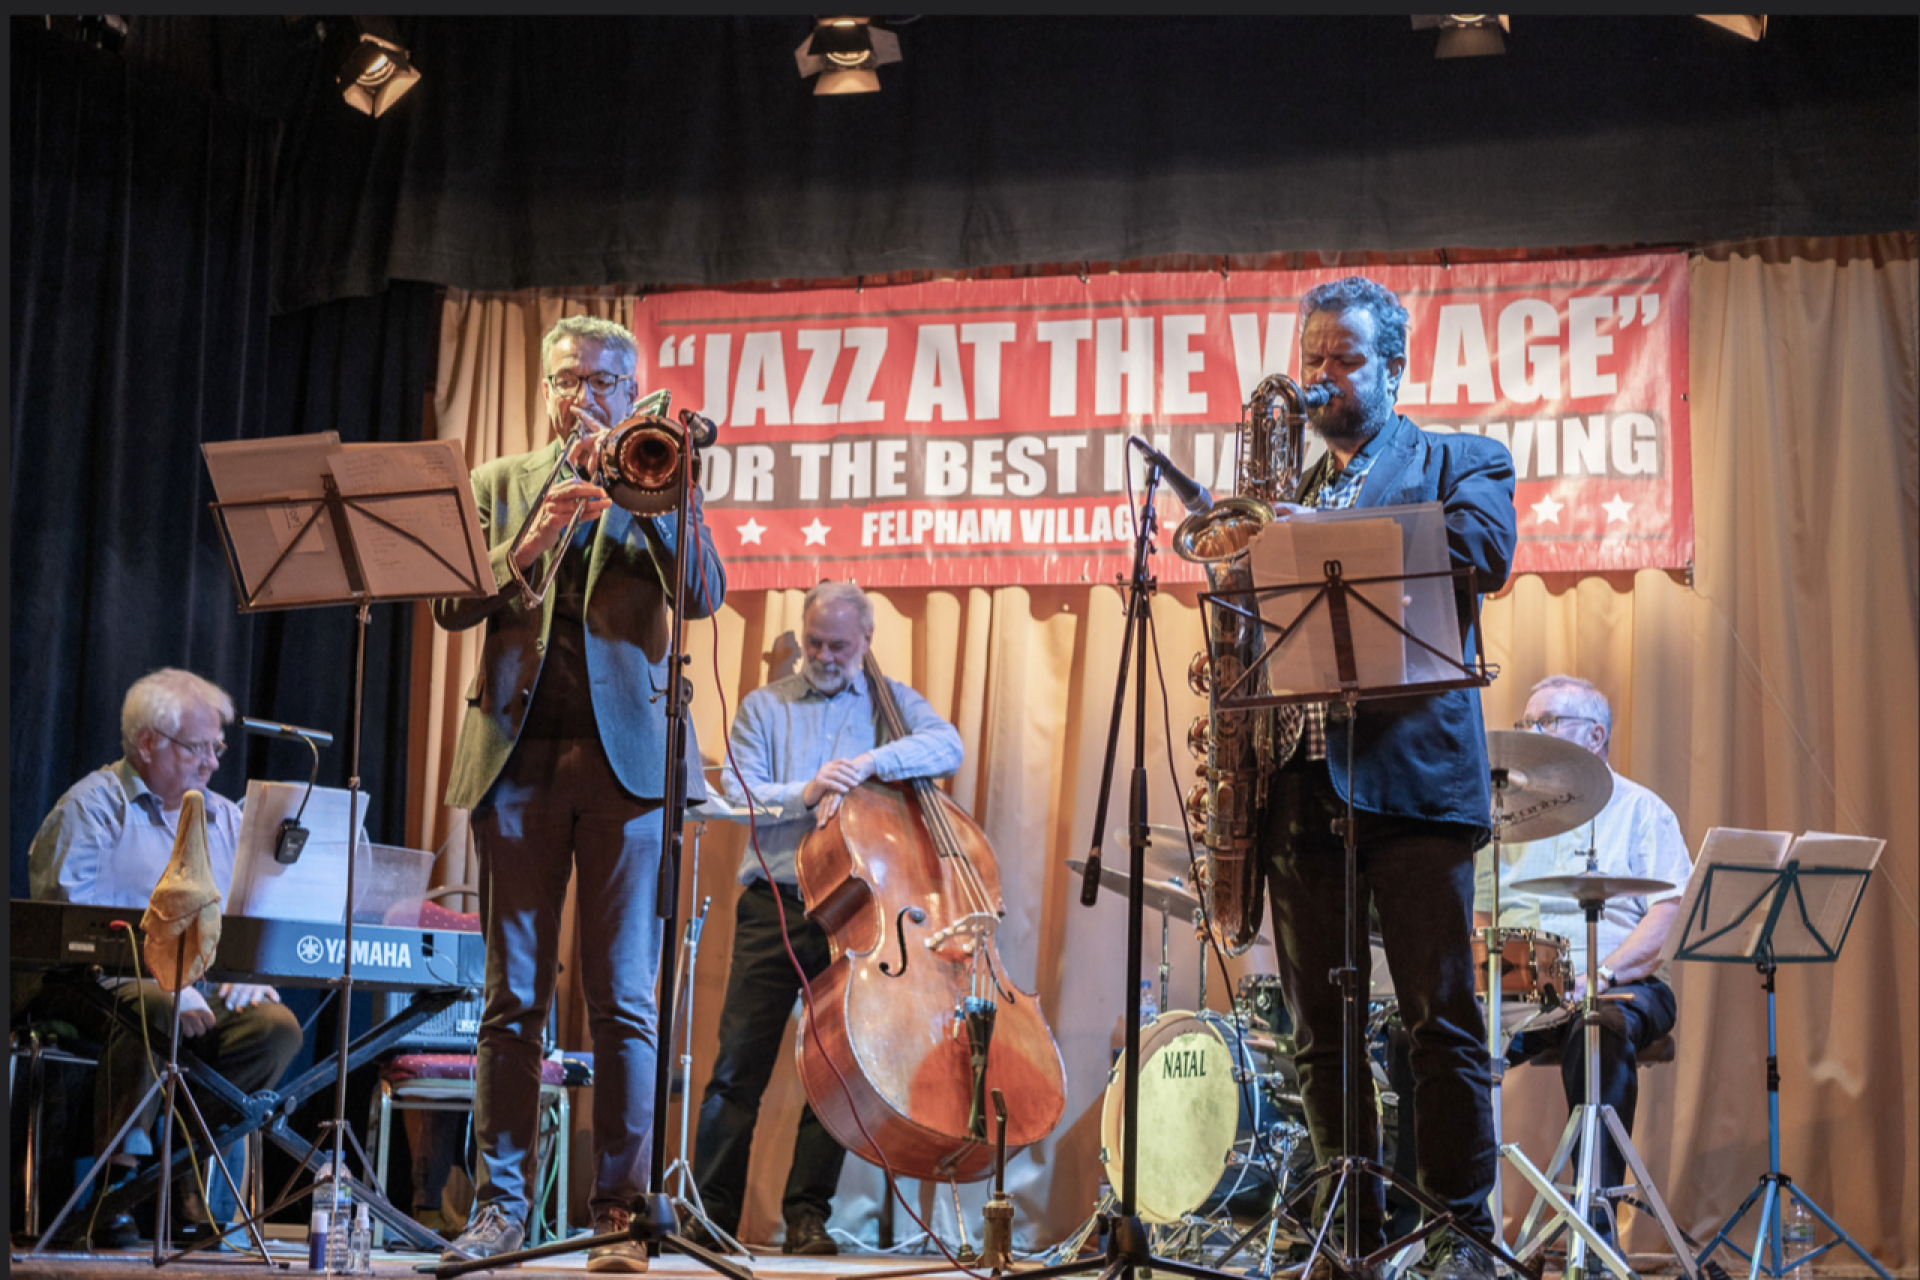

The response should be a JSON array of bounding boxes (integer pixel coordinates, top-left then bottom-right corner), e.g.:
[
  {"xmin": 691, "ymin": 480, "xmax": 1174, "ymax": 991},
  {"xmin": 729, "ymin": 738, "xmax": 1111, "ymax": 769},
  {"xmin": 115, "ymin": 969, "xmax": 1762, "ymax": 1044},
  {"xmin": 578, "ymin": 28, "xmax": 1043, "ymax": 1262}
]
[{"xmin": 27, "ymin": 668, "xmax": 301, "ymax": 1247}]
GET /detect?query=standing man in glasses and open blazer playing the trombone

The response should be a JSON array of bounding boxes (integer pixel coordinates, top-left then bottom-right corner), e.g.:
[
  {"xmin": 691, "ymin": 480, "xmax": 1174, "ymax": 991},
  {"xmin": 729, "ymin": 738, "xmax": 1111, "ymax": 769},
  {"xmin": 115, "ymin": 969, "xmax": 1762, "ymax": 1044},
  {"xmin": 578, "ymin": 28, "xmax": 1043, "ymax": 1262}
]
[{"xmin": 434, "ymin": 317, "xmax": 726, "ymax": 1270}]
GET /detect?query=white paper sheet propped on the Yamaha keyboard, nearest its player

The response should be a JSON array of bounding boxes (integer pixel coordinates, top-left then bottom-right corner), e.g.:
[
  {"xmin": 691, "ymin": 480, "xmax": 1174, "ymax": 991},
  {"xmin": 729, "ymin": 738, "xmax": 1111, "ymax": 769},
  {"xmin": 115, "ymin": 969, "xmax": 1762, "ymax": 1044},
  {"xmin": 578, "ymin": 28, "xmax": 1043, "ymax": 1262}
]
[{"xmin": 227, "ymin": 779, "xmax": 367, "ymax": 925}]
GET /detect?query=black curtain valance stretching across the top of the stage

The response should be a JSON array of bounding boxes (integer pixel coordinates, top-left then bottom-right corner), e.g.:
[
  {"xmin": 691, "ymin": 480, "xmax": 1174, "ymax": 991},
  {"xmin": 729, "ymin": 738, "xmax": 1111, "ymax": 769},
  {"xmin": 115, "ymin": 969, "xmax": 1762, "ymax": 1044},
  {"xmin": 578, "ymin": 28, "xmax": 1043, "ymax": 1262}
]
[{"xmin": 251, "ymin": 15, "xmax": 1920, "ymax": 307}]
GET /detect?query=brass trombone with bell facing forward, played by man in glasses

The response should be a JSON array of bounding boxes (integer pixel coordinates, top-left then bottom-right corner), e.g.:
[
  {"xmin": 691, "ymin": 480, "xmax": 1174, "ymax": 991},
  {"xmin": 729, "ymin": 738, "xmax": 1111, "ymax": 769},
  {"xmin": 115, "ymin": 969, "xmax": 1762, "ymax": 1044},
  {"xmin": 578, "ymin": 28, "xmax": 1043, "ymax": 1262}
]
[{"xmin": 507, "ymin": 391, "xmax": 708, "ymax": 604}]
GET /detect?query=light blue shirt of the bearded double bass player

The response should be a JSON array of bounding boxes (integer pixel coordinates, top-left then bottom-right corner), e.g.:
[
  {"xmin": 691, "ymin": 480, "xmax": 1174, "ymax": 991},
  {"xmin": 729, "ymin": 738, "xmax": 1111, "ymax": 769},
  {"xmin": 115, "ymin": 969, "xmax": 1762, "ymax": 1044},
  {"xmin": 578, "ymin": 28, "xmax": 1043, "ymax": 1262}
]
[{"xmin": 720, "ymin": 676, "xmax": 966, "ymax": 885}]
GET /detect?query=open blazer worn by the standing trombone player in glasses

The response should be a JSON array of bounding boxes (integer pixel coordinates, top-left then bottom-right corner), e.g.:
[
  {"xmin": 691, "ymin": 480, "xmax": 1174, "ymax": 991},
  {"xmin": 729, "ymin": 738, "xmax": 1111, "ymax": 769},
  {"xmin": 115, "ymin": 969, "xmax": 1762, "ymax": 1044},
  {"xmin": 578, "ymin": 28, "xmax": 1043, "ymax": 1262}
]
[{"xmin": 434, "ymin": 441, "xmax": 726, "ymax": 808}]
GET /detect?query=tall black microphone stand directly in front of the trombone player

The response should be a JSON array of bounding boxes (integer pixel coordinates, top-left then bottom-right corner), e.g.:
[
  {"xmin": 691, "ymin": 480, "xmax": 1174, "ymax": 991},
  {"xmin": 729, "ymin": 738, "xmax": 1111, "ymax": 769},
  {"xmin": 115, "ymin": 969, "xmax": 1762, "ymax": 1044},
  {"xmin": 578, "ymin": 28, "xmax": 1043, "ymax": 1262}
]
[{"xmin": 432, "ymin": 411, "xmax": 753, "ymax": 1280}]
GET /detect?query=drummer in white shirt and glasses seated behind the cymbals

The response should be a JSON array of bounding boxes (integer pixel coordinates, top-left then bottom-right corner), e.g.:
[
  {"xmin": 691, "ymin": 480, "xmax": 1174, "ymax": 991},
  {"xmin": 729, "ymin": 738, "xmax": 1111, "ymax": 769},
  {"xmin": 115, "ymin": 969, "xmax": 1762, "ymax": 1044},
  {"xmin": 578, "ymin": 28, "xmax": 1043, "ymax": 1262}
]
[{"xmin": 1473, "ymin": 676, "xmax": 1693, "ymax": 1236}]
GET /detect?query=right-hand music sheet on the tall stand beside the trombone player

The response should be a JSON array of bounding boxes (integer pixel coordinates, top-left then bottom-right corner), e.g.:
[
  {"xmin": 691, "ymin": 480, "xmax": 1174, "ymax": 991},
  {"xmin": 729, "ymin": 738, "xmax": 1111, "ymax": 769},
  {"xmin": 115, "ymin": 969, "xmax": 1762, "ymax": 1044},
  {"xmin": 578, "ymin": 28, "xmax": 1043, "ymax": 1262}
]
[{"xmin": 326, "ymin": 439, "xmax": 493, "ymax": 599}]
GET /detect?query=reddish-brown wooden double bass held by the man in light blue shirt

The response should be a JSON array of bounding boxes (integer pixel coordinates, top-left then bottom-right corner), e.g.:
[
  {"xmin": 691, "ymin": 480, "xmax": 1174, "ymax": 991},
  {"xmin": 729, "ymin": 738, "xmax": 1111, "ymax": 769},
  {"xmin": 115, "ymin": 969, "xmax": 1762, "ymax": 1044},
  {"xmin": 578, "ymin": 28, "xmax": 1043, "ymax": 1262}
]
[{"xmin": 795, "ymin": 651, "xmax": 1066, "ymax": 1182}]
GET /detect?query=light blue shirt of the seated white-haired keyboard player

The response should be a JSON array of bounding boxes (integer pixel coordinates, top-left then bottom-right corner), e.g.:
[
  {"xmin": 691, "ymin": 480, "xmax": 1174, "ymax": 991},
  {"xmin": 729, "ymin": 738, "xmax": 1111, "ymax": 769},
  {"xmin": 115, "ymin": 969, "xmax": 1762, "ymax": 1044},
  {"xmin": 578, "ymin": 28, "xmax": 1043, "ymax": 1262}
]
[{"xmin": 27, "ymin": 758, "xmax": 240, "ymax": 908}]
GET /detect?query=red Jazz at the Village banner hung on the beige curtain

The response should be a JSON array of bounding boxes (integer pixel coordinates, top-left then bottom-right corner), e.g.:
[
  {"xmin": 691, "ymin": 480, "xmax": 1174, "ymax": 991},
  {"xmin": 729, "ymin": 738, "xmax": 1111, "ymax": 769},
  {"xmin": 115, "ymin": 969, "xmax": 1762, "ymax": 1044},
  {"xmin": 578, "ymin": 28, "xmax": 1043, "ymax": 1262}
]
[{"xmin": 634, "ymin": 255, "xmax": 1693, "ymax": 589}]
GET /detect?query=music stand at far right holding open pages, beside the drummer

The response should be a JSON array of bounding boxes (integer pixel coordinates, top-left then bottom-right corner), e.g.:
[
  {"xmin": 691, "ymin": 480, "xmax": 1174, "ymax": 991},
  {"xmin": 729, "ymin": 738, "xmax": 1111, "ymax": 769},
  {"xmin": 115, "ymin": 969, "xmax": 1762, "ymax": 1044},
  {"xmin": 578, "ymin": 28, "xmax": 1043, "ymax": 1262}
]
[{"xmin": 1674, "ymin": 850, "xmax": 1893, "ymax": 1280}]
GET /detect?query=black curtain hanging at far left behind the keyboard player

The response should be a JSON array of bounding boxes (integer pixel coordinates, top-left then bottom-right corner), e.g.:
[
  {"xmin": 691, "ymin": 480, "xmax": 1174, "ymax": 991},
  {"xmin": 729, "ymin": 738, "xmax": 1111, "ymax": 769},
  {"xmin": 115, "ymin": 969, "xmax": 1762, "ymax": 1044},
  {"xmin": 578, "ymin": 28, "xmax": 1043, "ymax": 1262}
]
[{"xmin": 8, "ymin": 27, "xmax": 440, "ymax": 896}]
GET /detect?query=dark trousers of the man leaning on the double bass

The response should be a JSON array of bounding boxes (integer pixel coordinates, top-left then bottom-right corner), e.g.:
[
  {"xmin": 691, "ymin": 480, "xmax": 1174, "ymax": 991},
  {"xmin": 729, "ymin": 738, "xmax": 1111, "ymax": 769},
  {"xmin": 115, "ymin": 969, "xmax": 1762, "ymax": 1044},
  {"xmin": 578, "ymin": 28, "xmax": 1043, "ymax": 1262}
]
[{"xmin": 693, "ymin": 881, "xmax": 847, "ymax": 1234}]
